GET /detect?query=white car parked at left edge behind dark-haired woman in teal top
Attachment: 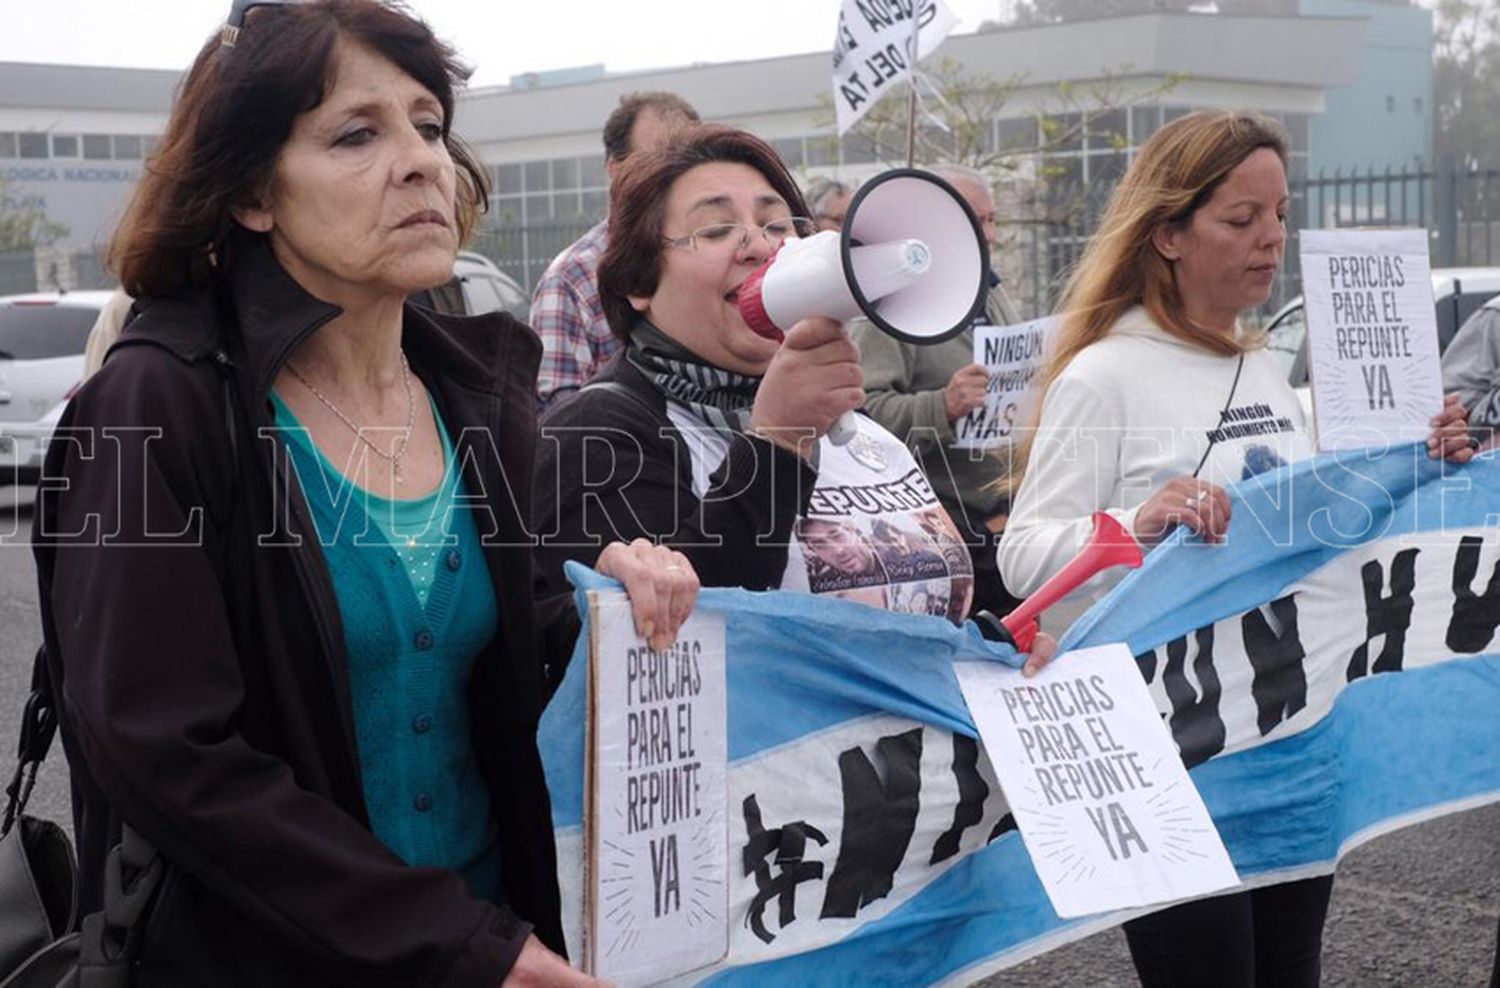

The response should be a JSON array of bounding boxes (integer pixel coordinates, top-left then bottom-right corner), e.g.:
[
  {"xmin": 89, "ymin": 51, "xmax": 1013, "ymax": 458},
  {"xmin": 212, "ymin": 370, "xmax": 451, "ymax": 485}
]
[{"xmin": 0, "ymin": 291, "xmax": 110, "ymax": 487}]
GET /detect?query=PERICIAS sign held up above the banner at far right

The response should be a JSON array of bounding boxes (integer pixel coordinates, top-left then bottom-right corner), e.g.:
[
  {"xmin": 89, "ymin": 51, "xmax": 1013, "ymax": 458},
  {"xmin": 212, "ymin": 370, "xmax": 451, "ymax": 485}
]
[{"xmin": 1302, "ymin": 229, "xmax": 1443, "ymax": 450}]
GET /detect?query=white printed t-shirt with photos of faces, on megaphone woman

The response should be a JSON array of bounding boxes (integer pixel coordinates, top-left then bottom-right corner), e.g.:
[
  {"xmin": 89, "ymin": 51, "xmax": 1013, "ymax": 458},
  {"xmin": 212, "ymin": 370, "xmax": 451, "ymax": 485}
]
[{"xmin": 668, "ymin": 402, "xmax": 974, "ymax": 624}]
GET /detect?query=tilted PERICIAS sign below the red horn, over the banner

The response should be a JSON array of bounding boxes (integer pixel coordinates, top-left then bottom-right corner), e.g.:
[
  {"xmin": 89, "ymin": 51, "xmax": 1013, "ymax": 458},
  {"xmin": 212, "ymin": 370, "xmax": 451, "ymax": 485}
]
[{"xmin": 954, "ymin": 645, "xmax": 1239, "ymax": 919}]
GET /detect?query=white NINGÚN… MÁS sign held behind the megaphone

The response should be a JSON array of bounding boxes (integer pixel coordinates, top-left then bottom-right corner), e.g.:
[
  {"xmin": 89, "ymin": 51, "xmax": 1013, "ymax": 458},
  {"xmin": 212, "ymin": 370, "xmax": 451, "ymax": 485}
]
[{"xmin": 953, "ymin": 316, "xmax": 1058, "ymax": 450}]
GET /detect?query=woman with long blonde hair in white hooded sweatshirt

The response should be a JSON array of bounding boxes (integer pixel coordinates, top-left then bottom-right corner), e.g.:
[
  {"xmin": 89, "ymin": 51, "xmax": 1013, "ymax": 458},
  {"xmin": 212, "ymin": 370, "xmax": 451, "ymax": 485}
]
[{"xmin": 999, "ymin": 111, "xmax": 1473, "ymax": 988}]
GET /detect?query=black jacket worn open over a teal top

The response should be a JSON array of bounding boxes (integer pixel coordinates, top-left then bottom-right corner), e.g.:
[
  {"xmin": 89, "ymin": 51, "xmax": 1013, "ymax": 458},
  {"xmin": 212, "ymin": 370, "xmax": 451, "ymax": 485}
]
[{"xmin": 35, "ymin": 237, "xmax": 576, "ymax": 987}]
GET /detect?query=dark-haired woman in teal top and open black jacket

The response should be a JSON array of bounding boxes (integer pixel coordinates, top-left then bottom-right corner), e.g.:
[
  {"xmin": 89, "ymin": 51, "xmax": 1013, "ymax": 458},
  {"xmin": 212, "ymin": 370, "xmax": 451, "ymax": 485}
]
[{"xmin": 36, "ymin": 0, "xmax": 696, "ymax": 987}]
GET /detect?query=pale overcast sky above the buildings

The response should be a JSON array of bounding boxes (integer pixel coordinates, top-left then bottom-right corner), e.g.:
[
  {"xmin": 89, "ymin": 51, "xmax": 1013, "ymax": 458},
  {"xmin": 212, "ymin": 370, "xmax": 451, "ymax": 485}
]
[{"xmin": 0, "ymin": 0, "xmax": 1005, "ymax": 85}]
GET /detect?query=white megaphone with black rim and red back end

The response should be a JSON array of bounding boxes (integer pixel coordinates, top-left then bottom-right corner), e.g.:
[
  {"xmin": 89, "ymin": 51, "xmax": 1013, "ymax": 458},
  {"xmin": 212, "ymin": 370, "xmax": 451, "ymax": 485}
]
[{"xmin": 737, "ymin": 168, "xmax": 990, "ymax": 445}]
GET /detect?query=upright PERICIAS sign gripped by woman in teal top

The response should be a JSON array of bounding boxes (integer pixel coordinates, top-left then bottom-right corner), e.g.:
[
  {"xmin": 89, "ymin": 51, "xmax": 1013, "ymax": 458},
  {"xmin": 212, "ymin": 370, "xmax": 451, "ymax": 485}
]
[{"xmin": 585, "ymin": 592, "xmax": 729, "ymax": 985}]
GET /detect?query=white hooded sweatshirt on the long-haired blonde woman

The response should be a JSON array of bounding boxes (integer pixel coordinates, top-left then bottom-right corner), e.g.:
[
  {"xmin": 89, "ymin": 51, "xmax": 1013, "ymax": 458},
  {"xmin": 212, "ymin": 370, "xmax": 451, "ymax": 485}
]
[{"xmin": 999, "ymin": 306, "xmax": 1314, "ymax": 628}]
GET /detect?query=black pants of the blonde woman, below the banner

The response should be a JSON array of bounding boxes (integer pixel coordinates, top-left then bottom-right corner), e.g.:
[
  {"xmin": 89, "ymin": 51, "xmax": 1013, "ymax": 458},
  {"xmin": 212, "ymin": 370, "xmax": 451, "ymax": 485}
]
[{"xmin": 1125, "ymin": 876, "xmax": 1334, "ymax": 988}]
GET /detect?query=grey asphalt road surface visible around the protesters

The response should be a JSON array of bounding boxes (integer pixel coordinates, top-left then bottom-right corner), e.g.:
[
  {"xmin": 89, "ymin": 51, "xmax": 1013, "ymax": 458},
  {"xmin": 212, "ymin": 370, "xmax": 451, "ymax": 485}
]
[{"xmin": 0, "ymin": 487, "xmax": 1500, "ymax": 988}]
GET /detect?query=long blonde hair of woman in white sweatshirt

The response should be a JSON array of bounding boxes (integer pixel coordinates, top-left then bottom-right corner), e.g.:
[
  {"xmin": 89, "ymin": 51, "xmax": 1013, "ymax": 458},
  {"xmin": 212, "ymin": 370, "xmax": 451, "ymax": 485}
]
[{"xmin": 1008, "ymin": 109, "xmax": 1287, "ymax": 490}]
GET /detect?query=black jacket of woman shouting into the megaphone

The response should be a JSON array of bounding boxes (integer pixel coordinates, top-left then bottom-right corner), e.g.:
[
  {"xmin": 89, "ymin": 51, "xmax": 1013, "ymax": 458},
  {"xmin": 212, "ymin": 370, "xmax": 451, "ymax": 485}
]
[{"xmin": 534, "ymin": 355, "xmax": 818, "ymax": 602}]
